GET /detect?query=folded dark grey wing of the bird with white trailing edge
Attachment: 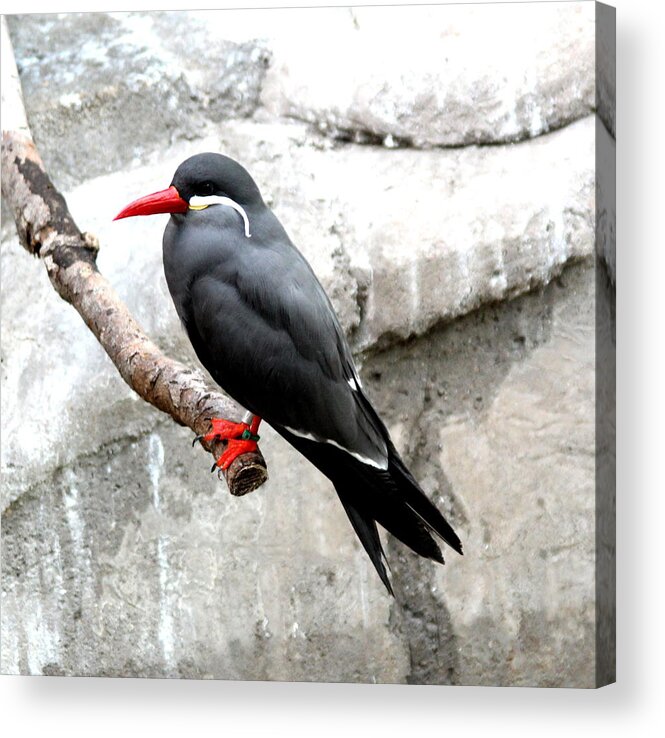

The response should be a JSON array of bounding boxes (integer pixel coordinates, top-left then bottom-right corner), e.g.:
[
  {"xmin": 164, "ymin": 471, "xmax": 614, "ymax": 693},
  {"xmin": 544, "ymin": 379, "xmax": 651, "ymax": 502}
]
[{"xmin": 185, "ymin": 247, "xmax": 388, "ymax": 468}]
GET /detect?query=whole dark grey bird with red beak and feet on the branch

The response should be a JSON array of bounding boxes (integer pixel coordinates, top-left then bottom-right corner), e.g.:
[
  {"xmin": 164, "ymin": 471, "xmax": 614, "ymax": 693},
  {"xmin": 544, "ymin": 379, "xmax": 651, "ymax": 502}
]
[{"xmin": 114, "ymin": 152, "xmax": 463, "ymax": 597}]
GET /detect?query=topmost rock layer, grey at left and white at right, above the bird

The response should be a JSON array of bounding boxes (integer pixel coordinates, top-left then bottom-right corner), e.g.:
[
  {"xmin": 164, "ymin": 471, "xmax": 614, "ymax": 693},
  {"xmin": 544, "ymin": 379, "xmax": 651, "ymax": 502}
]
[{"xmin": 5, "ymin": 2, "xmax": 596, "ymax": 187}]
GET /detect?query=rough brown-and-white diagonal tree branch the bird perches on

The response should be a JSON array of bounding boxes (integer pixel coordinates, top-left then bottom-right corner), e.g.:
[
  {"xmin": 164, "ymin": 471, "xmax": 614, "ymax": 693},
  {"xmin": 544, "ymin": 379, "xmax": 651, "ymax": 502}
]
[{"xmin": 2, "ymin": 17, "xmax": 268, "ymax": 495}]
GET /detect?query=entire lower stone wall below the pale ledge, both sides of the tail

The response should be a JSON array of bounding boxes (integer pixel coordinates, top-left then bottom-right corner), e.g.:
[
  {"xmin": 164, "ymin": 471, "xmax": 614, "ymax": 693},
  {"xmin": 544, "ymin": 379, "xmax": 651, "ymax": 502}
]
[{"xmin": 2, "ymin": 262, "xmax": 595, "ymax": 687}]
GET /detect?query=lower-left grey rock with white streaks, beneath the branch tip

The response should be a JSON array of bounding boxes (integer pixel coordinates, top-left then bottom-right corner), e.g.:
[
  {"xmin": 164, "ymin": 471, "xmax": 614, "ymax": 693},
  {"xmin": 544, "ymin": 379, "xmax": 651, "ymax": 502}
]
[{"xmin": 2, "ymin": 422, "xmax": 408, "ymax": 682}]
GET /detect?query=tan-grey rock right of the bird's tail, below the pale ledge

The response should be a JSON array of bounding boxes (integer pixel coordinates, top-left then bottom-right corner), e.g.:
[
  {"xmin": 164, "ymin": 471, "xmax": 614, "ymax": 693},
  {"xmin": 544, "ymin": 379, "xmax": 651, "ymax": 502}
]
[{"xmin": 363, "ymin": 263, "xmax": 596, "ymax": 687}]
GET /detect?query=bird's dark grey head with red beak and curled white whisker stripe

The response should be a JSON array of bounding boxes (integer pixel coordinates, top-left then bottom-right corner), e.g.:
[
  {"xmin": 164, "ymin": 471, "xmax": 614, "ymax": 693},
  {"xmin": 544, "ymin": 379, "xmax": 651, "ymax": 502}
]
[{"xmin": 114, "ymin": 153, "xmax": 263, "ymax": 236}]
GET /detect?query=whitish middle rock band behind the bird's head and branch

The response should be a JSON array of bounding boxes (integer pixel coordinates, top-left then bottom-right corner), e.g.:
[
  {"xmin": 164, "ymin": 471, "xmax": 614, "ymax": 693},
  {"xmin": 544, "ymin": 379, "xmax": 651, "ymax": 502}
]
[{"xmin": 2, "ymin": 118, "xmax": 594, "ymax": 508}]
